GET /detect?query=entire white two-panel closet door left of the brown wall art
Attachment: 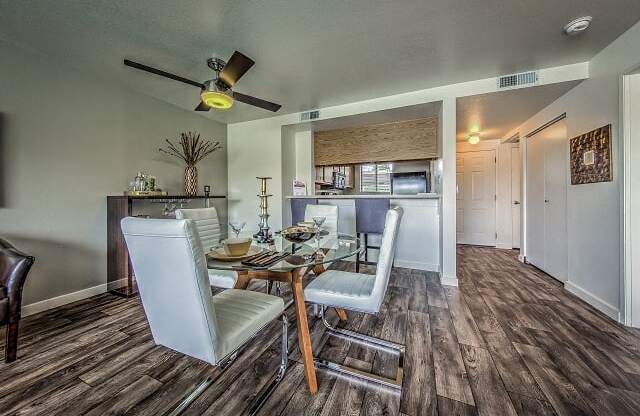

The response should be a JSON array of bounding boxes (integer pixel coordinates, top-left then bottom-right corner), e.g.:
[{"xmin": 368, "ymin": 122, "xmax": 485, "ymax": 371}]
[{"xmin": 525, "ymin": 117, "xmax": 568, "ymax": 282}]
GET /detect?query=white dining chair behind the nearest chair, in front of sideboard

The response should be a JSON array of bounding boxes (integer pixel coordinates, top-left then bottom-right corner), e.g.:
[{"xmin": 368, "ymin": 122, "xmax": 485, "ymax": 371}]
[{"xmin": 175, "ymin": 208, "xmax": 238, "ymax": 289}]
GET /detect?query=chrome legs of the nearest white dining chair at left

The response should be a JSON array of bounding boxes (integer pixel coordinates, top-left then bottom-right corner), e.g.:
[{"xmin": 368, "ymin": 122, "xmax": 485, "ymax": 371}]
[{"xmin": 166, "ymin": 314, "xmax": 289, "ymax": 416}]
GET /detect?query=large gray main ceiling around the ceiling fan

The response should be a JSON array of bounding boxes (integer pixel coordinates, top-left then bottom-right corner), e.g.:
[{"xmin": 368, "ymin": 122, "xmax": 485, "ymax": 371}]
[{"xmin": 0, "ymin": 0, "xmax": 640, "ymax": 122}]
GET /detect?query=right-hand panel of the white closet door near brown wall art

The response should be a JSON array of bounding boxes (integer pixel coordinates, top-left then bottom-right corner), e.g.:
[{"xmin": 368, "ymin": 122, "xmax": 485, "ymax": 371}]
[{"xmin": 542, "ymin": 120, "xmax": 568, "ymax": 282}]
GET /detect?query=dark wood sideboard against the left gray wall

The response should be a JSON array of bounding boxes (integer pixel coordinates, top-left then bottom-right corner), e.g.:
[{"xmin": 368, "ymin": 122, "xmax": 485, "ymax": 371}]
[{"xmin": 107, "ymin": 195, "xmax": 226, "ymax": 297}]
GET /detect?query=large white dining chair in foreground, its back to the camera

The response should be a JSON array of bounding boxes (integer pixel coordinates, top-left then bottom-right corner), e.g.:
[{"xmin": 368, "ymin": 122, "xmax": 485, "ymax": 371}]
[{"xmin": 121, "ymin": 217, "xmax": 288, "ymax": 415}]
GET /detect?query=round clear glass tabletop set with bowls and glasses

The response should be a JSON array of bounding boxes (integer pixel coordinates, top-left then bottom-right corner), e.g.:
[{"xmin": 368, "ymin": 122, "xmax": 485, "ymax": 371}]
[{"xmin": 207, "ymin": 234, "xmax": 361, "ymax": 272}]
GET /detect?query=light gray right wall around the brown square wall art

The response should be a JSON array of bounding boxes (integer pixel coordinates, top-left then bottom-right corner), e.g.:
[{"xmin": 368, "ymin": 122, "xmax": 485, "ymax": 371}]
[{"xmin": 506, "ymin": 18, "xmax": 640, "ymax": 317}]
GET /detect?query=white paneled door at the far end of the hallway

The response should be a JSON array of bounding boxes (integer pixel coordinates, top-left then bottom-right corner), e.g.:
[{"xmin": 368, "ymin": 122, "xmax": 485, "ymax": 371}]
[{"xmin": 456, "ymin": 150, "xmax": 496, "ymax": 246}]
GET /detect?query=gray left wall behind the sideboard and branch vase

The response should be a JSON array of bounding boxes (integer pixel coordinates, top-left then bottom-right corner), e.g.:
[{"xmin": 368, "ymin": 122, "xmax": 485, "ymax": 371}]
[{"xmin": 0, "ymin": 41, "xmax": 227, "ymax": 304}]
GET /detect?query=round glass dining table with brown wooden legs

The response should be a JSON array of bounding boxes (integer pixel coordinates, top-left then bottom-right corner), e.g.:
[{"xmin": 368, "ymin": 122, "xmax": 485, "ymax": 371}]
[{"xmin": 207, "ymin": 234, "xmax": 362, "ymax": 394}]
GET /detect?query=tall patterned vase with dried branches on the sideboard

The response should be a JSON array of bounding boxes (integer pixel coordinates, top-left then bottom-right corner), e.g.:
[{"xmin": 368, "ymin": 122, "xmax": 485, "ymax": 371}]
[{"xmin": 159, "ymin": 132, "xmax": 222, "ymax": 196}]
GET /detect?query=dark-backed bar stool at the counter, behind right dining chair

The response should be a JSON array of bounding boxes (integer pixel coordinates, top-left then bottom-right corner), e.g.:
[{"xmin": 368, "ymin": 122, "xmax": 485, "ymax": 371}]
[{"xmin": 355, "ymin": 198, "xmax": 390, "ymax": 273}]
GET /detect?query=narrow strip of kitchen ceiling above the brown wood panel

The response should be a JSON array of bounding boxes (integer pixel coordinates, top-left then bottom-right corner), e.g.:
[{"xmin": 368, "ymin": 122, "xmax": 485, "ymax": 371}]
[{"xmin": 311, "ymin": 102, "xmax": 441, "ymax": 131}]
